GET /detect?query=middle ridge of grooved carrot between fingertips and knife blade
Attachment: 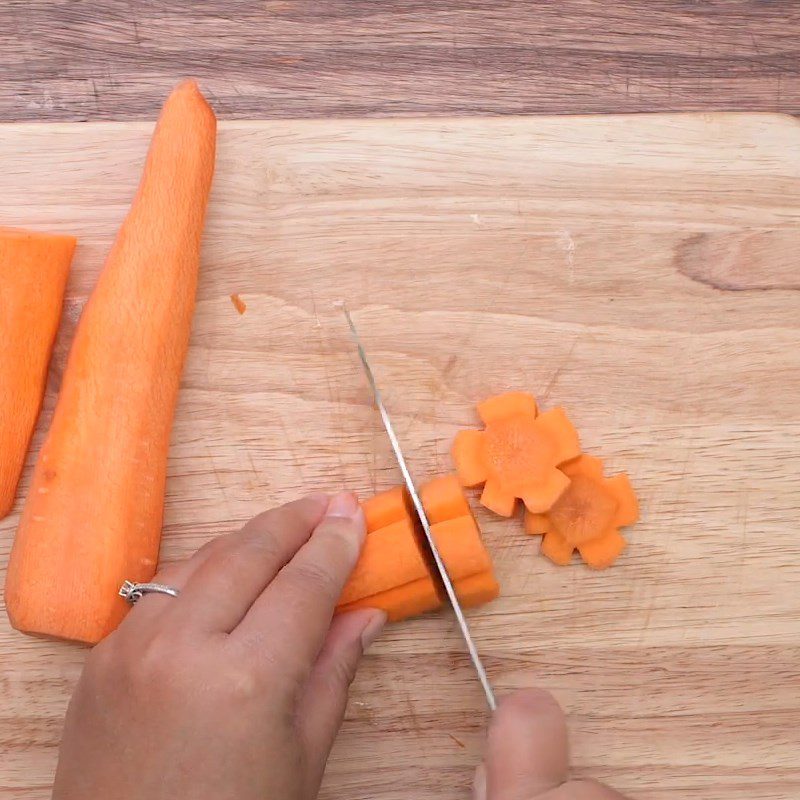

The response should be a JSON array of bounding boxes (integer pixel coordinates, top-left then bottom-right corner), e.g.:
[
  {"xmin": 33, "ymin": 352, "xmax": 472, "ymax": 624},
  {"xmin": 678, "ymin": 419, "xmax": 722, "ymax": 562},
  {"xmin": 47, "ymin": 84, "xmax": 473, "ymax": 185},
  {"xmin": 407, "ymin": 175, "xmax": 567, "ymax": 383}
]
[{"xmin": 339, "ymin": 518, "xmax": 430, "ymax": 605}]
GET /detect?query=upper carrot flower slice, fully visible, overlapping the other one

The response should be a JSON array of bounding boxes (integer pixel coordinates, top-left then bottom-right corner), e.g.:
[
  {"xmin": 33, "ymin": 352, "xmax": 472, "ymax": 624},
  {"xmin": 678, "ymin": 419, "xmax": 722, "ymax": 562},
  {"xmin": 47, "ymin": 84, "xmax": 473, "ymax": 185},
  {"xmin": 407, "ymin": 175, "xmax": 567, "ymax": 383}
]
[{"xmin": 453, "ymin": 392, "xmax": 581, "ymax": 517}]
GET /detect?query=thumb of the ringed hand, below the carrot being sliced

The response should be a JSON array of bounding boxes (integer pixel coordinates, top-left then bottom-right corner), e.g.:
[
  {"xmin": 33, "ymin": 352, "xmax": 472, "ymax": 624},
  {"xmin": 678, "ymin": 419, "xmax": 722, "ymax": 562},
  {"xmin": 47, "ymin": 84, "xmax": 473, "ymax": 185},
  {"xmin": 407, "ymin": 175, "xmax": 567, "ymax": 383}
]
[{"xmin": 297, "ymin": 608, "xmax": 386, "ymax": 780}]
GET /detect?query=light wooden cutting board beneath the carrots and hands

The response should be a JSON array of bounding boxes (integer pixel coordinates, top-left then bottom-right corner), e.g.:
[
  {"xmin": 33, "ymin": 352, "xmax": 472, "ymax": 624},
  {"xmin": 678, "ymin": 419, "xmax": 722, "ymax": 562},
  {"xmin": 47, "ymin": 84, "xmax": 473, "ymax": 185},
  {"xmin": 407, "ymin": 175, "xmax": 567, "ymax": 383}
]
[{"xmin": 0, "ymin": 114, "xmax": 800, "ymax": 800}]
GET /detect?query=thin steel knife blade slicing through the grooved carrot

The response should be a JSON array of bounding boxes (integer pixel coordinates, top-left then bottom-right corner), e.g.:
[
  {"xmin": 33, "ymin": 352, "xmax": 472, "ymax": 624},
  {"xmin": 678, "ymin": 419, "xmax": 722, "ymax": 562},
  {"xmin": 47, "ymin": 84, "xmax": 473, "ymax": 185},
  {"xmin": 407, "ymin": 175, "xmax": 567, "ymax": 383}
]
[{"xmin": 342, "ymin": 305, "xmax": 497, "ymax": 711}]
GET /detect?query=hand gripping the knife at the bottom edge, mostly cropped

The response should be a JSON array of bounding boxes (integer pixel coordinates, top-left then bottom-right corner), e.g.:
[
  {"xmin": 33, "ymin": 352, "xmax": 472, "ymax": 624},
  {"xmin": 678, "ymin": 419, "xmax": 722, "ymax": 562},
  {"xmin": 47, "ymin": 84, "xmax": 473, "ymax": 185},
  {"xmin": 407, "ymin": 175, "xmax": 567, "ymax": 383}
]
[{"xmin": 473, "ymin": 689, "xmax": 625, "ymax": 800}]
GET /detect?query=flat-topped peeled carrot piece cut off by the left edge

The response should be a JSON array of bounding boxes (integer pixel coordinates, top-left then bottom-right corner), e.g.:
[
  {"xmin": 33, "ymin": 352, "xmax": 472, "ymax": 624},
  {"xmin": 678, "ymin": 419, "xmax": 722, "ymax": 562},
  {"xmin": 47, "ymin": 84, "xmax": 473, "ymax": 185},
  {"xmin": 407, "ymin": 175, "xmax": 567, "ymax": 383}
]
[{"xmin": 0, "ymin": 228, "xmax": 75, "ymax": 519}]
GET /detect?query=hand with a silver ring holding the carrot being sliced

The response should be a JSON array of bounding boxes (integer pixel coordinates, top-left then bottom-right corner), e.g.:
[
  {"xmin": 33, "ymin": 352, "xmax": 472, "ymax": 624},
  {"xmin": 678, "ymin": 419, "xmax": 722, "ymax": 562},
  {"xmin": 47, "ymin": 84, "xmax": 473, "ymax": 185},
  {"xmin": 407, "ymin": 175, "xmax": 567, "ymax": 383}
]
[{"xmin": 53, "ymin": 494, "xmax": 385, "ymax": 800}]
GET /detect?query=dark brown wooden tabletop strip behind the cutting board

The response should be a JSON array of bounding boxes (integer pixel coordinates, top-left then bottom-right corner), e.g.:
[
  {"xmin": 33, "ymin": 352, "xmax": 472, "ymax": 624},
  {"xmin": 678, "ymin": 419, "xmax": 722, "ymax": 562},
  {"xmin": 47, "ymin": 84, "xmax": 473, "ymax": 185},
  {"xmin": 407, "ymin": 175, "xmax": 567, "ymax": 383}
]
[{"xmin": 0, "ymin": 0, "xmax": 800, "ymax": 121}]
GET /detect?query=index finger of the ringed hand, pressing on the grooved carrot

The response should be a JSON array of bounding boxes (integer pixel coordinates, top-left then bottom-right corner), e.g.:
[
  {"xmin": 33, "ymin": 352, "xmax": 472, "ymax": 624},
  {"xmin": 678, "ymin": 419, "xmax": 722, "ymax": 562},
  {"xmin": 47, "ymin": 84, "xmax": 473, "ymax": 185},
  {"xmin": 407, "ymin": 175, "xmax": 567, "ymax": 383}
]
[{"xmin": 232, "ymin": 492, "xmax": 367, "ymax": 679}]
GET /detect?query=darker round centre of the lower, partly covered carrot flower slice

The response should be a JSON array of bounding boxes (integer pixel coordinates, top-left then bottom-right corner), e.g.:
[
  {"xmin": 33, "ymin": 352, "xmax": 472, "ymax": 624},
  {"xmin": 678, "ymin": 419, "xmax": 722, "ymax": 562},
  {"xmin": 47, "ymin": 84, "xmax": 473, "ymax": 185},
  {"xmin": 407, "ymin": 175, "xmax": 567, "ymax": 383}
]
[{"xmin": 548, "ymin": 475, "xmax": 618, "ymax": 545}]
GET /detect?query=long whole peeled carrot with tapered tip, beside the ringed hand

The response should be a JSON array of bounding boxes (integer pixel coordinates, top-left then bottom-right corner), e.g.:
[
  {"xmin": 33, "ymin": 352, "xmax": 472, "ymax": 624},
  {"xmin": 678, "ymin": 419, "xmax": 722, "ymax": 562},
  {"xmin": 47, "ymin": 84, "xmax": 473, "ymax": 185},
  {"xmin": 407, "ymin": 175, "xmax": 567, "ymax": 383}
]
[{"xmin": 5, "ymin": 81, "xmax": 216, "ymax": 643}]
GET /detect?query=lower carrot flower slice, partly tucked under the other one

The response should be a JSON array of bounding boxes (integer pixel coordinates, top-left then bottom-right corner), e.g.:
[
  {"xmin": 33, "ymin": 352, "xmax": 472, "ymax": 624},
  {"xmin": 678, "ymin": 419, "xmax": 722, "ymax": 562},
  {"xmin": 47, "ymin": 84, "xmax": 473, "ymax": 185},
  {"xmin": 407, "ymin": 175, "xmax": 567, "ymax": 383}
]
[{"xmin": 525, "ymin": 455, "xmax": 639, "ymax": 569}]
